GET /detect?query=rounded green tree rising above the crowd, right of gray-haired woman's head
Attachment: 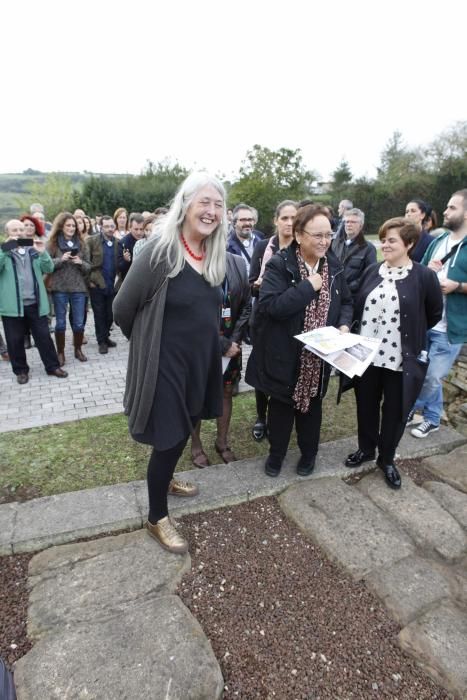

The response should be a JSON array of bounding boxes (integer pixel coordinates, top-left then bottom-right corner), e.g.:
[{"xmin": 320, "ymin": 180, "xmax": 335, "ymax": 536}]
[{"xmin": 229, "ymin": 144, "xmax": 316, "ymax": 232}]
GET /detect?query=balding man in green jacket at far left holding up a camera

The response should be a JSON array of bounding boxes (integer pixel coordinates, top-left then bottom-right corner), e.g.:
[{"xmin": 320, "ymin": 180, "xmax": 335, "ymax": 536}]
[{"xmin": 0, "ymin": 219, "xmax": 68, "ymax": 384}]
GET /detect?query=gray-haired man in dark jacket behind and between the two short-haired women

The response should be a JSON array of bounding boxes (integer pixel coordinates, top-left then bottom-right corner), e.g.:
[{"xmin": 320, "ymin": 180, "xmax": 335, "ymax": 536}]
[{"xmin": 332, "ymin": 208, "xmax": 376, "ymax": 296}]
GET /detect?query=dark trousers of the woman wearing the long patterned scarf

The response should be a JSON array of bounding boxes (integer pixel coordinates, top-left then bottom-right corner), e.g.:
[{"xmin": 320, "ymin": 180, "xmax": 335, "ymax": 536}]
[{"xmin": 268, "ymin": 398, "xmax": 322, "ymax": 462}]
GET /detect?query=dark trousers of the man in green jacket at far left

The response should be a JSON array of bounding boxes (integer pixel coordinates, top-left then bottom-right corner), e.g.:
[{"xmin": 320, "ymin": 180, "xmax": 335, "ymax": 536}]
[{"xmin": 2, "ymin": 304, "xmax": 60, "ymax": 374}]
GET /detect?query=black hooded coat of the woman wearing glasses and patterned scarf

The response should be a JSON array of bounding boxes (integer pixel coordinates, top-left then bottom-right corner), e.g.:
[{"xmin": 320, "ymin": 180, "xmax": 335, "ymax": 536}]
[{"xmin": 245, "ymin": 241, "xmax": 353, "ymax": 404}]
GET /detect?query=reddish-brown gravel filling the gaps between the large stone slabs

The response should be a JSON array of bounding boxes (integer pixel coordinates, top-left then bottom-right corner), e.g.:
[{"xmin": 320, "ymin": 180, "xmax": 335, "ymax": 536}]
[{"xmin": 0, "ymin": 460, "xmax": 452, "ymax": 700}]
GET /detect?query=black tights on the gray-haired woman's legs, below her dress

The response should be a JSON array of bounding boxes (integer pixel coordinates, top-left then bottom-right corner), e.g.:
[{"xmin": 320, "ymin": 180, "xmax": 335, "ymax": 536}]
[{"xmin": 148, "ymin": 435, "xmax": 189, "ymax": 525}]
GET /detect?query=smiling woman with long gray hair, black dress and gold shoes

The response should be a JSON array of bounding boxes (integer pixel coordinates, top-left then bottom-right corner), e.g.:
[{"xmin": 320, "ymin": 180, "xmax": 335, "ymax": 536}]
[{"xmin": 113, "ymin": 173, "xmax": 227, "ymax": 554}]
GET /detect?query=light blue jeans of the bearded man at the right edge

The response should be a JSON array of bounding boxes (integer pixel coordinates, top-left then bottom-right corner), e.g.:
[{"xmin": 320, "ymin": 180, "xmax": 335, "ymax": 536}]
[{"xmin": 415, "ymin": 330, "xmax": 462, "ymax": 425}]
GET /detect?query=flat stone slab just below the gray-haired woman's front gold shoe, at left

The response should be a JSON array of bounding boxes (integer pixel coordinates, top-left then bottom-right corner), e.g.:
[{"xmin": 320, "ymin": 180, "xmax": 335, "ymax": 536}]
[{"xmin": 28, "ymin": 530, "xmax": 191, "ymax": 639}]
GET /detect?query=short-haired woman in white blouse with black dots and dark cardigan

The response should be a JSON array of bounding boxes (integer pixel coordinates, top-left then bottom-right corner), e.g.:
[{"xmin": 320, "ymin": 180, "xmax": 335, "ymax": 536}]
[{"xmin": 345, "ymin": 217, "xmax": 443, "ymax": 489}]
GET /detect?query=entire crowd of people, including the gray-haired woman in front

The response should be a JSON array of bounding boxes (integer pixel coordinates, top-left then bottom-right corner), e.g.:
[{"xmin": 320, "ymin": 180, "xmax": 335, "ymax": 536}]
[{"xmin": 0, "ymin": 183, "xmax": 467, "ymax": 553}]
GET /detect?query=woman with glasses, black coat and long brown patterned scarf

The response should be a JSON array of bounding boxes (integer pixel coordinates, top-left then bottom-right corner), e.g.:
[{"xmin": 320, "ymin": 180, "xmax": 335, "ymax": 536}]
[{"xmin": 246, "ymin": 204, "xmax": 352, "ymax": 476}]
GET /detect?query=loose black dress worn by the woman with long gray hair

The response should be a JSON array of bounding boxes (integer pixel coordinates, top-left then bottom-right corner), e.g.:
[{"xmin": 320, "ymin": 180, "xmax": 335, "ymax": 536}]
[{"xmin": 133, "ymin": 263, "xmax": 223, "ymax": 450}]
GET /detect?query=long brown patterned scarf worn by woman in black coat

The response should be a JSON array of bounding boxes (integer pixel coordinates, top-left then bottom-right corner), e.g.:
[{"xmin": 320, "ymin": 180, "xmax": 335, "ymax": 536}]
[{"xmin": 293, "ymin": 247, "xmax": 331, "ymax": 413}]
